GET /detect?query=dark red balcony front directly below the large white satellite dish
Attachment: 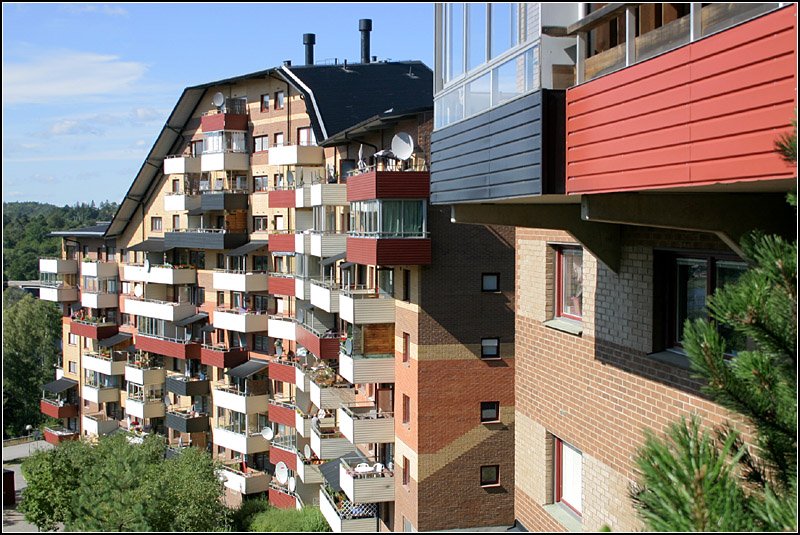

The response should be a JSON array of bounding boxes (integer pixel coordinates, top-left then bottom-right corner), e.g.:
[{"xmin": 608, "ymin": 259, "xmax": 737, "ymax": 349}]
[{"xmin": 347, "ymin": 171, "xmax": 431, "ymax": 202}]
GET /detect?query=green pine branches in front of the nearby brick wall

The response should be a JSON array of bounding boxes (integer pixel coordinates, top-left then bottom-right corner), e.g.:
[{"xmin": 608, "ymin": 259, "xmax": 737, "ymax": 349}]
[{"xmin": 631, "ymin": 131, "xmax": 797, "ymax": 531}]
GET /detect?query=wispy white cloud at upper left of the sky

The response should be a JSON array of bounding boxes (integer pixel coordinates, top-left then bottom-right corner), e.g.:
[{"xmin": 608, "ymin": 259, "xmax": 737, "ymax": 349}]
[{"xmin": 3, "ymin": 50, "xmax": 147, "ymax": 105}]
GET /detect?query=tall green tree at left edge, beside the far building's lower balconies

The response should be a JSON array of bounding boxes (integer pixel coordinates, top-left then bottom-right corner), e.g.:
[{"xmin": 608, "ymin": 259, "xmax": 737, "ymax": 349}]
[{"xmin": 3, "ymin": 294, "xmax": 61, "ymax": 436}]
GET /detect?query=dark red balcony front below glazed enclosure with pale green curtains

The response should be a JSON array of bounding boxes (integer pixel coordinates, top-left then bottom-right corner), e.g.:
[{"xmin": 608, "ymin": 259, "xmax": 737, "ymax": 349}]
[{"xmin": 347, "ymin": 236, "xmax": 431, "ymax": 266}]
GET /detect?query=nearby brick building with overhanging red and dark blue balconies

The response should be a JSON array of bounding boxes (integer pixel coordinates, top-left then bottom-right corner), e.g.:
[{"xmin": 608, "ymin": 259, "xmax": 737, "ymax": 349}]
[{"xmin": 431, "ymin": 3, "xmax": 797, "ymax": 531}]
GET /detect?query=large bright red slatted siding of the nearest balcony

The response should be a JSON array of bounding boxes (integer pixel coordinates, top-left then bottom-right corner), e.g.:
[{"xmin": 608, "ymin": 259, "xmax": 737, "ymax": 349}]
[{"xmin": 567, "ymin": 5, "xmax": 797, "ymax": 193}]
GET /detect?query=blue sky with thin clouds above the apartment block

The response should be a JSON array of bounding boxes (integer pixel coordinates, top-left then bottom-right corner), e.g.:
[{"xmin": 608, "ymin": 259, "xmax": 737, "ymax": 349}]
[{"xmin": 2, "ymin": 3, "xmax": 433, "ymax": 205}]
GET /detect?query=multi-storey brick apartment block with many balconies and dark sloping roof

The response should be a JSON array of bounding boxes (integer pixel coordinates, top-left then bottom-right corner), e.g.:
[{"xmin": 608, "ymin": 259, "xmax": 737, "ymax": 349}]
[{"xmin": 40, "ymin": 19, "xmax": 515, "ymax": 531}]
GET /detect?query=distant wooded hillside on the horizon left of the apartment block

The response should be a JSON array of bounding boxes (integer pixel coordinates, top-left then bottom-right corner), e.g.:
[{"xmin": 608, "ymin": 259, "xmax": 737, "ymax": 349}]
[{"xmin": 3, "ymin": 201, "xmax": 117, "ymax": 281}]
